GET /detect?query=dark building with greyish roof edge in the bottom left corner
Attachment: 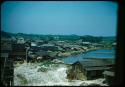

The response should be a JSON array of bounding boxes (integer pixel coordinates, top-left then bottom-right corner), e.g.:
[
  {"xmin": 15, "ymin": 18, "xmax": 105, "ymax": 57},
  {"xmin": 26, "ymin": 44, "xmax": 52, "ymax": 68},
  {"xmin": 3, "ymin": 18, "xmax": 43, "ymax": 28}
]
[{"xmin": 0, "ymin": 53, "xmax": 14, "ymax": 86}]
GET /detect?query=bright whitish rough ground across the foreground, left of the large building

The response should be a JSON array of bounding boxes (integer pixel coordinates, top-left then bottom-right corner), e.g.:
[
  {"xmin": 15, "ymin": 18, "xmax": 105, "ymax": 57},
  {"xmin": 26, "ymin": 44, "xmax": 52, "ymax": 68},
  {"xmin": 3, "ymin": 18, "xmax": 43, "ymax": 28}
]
[{"xmin": 14, "ymin": 63, "xmax": 105, "ymax": 86}]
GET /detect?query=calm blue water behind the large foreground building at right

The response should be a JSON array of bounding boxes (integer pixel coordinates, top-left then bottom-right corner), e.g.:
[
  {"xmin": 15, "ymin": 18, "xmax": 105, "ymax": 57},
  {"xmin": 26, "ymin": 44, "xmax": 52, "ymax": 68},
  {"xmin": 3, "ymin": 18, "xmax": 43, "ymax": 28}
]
[{"xmin": 61, "ymin": 49, "xmax": 115, "ymax": 64}]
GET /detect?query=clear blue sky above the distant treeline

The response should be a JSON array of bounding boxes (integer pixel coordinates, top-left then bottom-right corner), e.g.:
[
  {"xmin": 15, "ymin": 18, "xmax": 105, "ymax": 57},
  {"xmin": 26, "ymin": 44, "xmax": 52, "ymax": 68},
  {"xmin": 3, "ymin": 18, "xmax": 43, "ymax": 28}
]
[{"xmin": 1, "ymin": 1, "xmax": 118, "ymax": 36}]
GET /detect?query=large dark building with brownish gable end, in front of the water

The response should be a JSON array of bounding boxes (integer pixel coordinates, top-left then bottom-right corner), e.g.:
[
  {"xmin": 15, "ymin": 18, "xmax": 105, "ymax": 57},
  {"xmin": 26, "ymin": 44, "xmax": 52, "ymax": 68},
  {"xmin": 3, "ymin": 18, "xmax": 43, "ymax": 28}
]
[{"xmin": 67, "ymin": 59, "xmax": 114, "ymax": 80}]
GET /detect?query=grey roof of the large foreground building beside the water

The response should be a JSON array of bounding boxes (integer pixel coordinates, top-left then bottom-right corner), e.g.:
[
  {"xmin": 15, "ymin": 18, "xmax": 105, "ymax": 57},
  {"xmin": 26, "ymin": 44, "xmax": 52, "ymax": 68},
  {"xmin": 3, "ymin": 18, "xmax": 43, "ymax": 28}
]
[{"xmin": 73, "ymin": 59, "xmax": 114, "ymax": 71}]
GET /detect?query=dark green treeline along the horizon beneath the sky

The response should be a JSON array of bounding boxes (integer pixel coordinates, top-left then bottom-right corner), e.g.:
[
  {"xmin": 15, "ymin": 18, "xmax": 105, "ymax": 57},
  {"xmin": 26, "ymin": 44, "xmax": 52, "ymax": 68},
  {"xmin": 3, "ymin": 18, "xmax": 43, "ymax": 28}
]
[{"xmin": 1, "ymin": 31, "xmax": 116, "ymax": 43}]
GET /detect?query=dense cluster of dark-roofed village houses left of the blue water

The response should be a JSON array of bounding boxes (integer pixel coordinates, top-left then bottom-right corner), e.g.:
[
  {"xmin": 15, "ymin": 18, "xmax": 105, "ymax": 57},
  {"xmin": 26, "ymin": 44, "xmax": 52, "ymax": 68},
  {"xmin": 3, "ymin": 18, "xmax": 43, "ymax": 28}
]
[{"xmin": 2, "ymin": 37, "xmax": 106, "ymax": 61}]
